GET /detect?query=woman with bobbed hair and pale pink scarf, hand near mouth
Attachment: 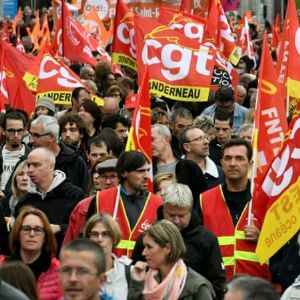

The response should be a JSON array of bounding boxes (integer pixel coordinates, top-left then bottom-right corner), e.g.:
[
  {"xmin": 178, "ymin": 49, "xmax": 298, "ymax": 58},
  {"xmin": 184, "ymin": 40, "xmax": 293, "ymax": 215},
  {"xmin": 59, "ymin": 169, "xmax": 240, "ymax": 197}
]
[{"xmin": 127, "ymin": 220, "xmax": 214, "ymax": 300}]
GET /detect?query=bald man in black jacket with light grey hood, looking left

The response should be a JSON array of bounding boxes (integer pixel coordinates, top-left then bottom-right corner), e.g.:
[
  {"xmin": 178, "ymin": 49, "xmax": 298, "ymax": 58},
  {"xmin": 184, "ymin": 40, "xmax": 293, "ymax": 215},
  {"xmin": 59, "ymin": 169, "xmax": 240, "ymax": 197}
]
[{"xmin": 16, "ymin": 147, "xmax": 85, "ymax": 247}]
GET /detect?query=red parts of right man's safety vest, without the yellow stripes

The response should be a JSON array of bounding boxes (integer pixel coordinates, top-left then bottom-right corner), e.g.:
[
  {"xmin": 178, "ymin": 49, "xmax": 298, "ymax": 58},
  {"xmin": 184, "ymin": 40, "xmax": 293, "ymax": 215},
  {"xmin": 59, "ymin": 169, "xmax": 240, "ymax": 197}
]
[{"xmin": 200, "ymin": 185, "xmax": 271, "ymax": 280}]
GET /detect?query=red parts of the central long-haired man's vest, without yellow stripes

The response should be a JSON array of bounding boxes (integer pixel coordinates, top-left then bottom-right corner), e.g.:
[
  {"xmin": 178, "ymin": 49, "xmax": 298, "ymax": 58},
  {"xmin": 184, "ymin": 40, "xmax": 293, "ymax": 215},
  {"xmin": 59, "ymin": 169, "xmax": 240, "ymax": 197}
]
[{"xmin": 97, "ymin": 187, "xmax": 162, "ymax": 257}]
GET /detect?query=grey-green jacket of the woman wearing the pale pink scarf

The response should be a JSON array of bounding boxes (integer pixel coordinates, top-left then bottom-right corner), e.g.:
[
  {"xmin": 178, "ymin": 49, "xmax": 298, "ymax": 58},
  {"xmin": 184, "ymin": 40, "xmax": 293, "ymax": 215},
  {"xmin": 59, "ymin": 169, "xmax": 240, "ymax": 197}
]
[{"xmin": 127, "ymin": 268, "xmax": 215, "ymax": 300}]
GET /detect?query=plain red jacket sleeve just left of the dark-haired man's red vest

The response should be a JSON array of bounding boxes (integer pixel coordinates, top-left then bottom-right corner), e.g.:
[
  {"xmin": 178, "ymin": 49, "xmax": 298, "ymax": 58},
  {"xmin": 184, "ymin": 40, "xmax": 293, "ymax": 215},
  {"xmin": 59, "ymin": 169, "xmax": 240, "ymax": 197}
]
[{"xmin": 63, "ymin": 196, "xmax": 94, "ymax": 245}]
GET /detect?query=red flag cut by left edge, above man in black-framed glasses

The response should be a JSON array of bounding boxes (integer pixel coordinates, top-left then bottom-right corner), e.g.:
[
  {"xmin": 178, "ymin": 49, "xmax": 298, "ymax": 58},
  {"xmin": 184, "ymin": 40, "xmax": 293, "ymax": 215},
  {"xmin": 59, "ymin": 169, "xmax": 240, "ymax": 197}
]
[{"xmin": 0, "ymin": 41, "xmax": 35, "ymax": 115}]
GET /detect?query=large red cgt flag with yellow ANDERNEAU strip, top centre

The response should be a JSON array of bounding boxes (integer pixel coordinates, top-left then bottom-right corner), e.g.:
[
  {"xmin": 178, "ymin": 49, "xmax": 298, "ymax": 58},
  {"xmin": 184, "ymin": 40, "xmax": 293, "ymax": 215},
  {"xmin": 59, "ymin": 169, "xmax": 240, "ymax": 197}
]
[{"xmin": 135, "ymin": 17, "xmax": 215, "ymax": 101}]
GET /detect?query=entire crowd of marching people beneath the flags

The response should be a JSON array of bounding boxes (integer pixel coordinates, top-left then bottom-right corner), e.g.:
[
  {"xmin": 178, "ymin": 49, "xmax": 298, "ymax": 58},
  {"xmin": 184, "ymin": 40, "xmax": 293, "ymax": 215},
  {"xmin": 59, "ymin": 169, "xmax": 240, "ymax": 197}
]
[{"xmin": 0, "ymin": 2, "xmax": 300, "ymax": 300}]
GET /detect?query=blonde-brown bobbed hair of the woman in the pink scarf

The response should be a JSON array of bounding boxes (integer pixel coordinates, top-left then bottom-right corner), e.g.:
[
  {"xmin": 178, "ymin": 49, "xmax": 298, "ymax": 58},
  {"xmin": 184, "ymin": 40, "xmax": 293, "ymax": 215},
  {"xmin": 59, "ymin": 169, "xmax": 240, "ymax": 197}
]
[{"xmin": 144, "ymin": 220, "xmax": 186, "ymax": 263}]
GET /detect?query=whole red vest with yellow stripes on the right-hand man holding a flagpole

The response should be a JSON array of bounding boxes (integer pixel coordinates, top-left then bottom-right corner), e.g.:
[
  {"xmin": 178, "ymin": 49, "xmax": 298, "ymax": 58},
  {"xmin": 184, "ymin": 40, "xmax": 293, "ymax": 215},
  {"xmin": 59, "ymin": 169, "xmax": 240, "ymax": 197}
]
[{"xmin": 200, "ymin": 185, "xmax": 271, "ymax": 281}]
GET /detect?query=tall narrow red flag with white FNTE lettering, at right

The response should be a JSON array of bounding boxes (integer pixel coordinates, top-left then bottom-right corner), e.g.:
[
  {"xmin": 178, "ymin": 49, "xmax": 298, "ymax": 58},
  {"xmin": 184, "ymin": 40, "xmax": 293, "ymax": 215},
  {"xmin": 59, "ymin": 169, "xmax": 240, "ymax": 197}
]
[{"xmin": 253, "ymin": 32, "xmax": 288, "ymax": 190}]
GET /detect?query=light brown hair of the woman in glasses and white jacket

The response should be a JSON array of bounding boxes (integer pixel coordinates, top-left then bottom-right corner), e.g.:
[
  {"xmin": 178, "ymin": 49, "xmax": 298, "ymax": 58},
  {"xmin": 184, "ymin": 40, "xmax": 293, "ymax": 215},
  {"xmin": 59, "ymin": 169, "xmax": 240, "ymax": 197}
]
[{"xmin": 83, "ymin": 214, "xmax": 122, "ymax": 249}]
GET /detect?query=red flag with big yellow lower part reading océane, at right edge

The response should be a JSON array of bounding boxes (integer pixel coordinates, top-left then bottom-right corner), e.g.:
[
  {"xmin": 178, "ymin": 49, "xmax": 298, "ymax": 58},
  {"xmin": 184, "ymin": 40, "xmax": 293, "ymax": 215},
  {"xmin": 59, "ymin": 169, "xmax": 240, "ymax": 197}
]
[{"xmin": 256, "ymin": 110, "xmax": 300, "ymax": 263}]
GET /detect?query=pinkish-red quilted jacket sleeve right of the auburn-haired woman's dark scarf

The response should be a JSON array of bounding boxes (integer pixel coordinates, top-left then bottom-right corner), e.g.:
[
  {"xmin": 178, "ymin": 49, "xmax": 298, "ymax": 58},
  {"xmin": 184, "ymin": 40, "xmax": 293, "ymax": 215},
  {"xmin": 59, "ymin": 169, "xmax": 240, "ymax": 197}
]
[{"xmin": 37, "ymin": 257, "xmax": 63, "ymax": 300}]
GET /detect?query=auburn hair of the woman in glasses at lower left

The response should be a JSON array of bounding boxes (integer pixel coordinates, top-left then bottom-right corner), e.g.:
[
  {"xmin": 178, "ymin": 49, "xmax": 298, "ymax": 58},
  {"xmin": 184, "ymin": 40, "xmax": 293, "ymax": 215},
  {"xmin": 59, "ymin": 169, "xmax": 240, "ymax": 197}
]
[{"xmin": 9, "ymin": 206, "xmax": 57, "ymax": 256}]
